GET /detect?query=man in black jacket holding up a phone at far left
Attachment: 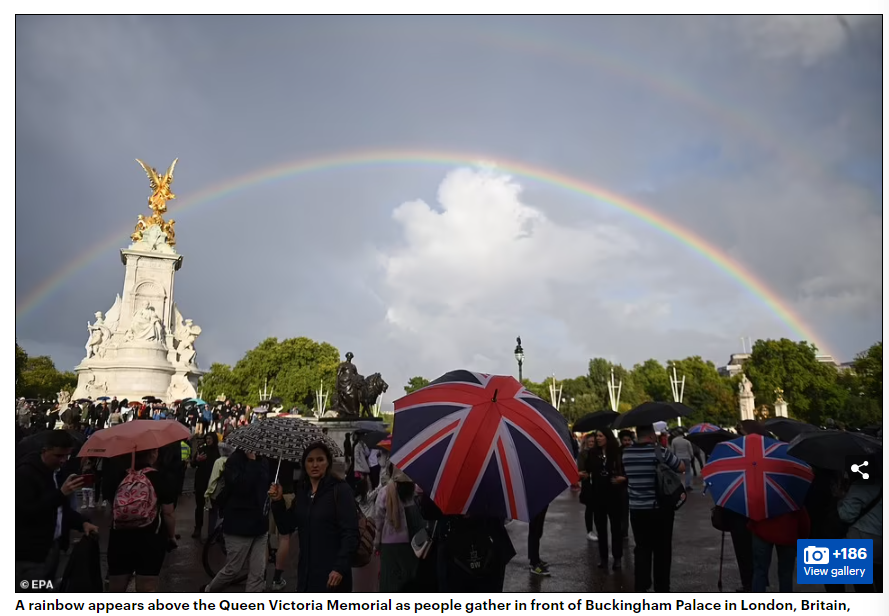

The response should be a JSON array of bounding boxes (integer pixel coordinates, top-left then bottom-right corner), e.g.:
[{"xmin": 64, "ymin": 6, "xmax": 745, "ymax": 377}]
[{"xmin": 15, "ymin": 430, "xmax": 99, "ymax": 591}]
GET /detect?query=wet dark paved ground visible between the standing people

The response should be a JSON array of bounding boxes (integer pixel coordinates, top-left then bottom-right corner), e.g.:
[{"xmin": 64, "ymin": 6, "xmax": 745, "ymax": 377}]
[{"xmin": 80, "ymin": 476, "xmax": 823, "ymax": 592}]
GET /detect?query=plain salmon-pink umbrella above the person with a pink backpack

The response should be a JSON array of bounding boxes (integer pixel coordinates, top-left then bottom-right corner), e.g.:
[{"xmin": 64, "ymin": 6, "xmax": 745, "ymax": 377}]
[{"xmin": 78, "ymin": 419, "xmax": 191, "ymax": 458}]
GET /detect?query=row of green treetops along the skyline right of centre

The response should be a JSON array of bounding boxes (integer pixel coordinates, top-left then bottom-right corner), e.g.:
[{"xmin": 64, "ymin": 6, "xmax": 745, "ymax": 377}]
[{"xmin": 404, "ymin": 339, "xmax": 883, "ymax": 427}]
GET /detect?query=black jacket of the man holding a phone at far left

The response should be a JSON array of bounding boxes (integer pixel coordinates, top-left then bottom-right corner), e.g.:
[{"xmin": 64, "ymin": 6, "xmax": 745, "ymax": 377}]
[{"xmin": 15, "ymin": 452, "xmax": 84, "ymax": 562}]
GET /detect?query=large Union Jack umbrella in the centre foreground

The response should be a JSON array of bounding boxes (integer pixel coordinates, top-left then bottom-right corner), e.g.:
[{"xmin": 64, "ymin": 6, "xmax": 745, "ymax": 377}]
[{"xmin": 390, "ymin": 370, "xmax": 579, "ymax": 522}]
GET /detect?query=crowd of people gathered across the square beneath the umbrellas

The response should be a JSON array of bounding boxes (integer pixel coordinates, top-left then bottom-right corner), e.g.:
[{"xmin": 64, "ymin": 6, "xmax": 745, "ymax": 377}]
[{"xmin": 15, "ymin": 399, "xmax": 882, "ymax": 592}]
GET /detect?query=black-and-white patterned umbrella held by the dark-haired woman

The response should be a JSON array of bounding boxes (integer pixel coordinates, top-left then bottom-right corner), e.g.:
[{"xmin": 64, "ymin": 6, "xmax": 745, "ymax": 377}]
[{"xmin": 225, "ymin": 417, "xmax": 343, "ymax": 462}]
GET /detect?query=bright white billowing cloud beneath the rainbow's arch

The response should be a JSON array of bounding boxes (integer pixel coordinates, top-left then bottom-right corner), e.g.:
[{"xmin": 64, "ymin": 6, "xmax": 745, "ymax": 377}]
[{"xmin": 380, "ymin": 168, "xmax": 639, "ymax": 368}]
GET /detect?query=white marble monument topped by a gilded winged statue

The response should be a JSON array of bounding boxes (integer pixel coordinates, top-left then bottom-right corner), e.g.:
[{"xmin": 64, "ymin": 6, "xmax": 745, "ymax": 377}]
[{"xmin": 74, "ymin": 161, "xmax": 202, "ymax": 401}]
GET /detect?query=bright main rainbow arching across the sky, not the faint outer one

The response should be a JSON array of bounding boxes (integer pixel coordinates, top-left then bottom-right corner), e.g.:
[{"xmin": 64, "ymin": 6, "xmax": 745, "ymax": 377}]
[{"xmin": 16, "ymin": 150, "xmax": 827, "ymax": 352}]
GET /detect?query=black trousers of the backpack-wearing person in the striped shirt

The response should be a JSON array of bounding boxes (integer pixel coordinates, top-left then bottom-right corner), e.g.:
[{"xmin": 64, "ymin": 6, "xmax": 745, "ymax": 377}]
[{"xmin": 632, "ymin": 509, "xmax": 675, "ymax": 592}]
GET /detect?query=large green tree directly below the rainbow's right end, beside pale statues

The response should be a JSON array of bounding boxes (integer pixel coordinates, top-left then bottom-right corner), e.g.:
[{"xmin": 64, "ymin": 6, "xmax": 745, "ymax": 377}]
[{"xmin": 744, "ymin": 338, "xmax": 847, "ymax": 425}]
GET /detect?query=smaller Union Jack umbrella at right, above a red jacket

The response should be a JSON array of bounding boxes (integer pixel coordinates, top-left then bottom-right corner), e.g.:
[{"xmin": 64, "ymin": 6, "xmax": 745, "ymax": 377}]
[{"xmin": 701, "ymin": 434, "xmax": 814, "ymax": 522}]
